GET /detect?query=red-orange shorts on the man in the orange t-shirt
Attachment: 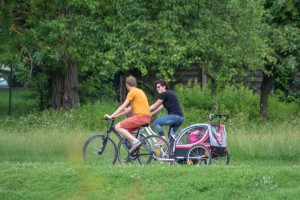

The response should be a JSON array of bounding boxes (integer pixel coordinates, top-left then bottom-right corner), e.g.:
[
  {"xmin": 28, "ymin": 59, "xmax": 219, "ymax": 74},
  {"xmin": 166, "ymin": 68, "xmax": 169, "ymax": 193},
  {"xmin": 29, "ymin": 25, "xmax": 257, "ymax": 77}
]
[{"xmin": 120, "ymin": 115, "xmax": 151, "ymax": 133}]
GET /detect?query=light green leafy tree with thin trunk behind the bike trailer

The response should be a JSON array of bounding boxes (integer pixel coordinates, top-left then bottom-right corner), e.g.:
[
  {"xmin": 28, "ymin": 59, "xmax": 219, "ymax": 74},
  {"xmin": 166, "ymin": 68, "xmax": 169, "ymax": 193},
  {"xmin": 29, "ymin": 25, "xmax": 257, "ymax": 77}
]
[{"xmin": 106, "ymin": 0, "xmax": 264, "ymax": 109}]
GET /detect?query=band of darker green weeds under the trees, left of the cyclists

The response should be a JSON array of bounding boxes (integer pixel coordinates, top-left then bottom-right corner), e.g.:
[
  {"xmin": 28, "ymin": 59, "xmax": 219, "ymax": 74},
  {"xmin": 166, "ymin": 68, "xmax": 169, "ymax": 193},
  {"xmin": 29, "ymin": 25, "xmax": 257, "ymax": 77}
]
[{"xmin": 0, "ymin": 101, "xmax": 118, "ymax": 133}]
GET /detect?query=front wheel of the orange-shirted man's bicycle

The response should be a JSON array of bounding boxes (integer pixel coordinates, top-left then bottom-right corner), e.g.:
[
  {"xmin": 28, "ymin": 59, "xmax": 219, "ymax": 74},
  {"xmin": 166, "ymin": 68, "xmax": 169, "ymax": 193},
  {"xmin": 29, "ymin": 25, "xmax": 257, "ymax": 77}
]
[{"xmin": 83, "ymin": 135, "xmax": 117, "ymax": 166}]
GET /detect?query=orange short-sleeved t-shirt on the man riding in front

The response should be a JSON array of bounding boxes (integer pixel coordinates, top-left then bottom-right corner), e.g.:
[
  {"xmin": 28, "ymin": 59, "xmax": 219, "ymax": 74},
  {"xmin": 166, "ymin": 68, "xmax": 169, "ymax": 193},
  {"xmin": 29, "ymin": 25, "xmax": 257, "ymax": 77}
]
[{"xmin": 126, "ymin": 88, "xmax": 150, "ymax": 116}]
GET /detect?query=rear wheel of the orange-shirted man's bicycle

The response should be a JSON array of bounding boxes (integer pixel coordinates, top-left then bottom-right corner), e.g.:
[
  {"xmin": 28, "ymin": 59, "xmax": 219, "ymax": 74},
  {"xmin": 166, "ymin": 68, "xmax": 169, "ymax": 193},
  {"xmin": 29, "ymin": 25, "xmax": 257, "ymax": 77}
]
[{"xmin": 134, "ymin": 135, "xmax": 170, "ymax": 165}]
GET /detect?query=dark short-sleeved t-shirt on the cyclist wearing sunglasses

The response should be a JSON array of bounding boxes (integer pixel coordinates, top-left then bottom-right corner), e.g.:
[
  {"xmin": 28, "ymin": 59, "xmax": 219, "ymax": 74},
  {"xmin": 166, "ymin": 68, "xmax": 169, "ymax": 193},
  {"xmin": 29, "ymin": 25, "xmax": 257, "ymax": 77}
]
[{"xmin": 158, "ymin": 90, "xmax": 183, "ymax": 116}]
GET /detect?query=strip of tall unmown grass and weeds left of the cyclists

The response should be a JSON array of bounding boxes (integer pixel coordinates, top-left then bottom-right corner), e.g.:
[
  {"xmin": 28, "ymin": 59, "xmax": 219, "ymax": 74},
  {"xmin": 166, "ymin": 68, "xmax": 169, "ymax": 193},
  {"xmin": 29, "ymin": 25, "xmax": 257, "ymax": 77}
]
[{"xmin": 0, "ymin": 102, "xmax": 118, "ymax": 161}]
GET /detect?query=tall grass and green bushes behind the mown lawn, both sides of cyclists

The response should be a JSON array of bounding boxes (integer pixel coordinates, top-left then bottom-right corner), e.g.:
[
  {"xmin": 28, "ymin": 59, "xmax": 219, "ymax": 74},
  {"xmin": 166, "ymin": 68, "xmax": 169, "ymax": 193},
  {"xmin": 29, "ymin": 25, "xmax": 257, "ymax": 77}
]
[{"xmin": 0, "ymin": 86, "xmax": 300, "ymax": 164}]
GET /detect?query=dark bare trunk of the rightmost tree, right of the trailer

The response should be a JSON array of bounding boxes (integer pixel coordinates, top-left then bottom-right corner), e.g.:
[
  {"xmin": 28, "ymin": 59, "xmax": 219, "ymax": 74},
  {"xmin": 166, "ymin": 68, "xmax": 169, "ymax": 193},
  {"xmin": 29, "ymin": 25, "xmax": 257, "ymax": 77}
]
[{"xmin": 260, "ymin": 67, "xmax": 273, "ymax": 120}]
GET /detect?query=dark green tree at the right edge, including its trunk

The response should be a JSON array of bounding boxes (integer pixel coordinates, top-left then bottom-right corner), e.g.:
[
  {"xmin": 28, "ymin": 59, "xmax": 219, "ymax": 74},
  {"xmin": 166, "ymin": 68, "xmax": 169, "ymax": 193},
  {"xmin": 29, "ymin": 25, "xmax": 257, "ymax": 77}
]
[{"xmin": 260, "ymin": 0, "xmax": 300, "ymax": 119}]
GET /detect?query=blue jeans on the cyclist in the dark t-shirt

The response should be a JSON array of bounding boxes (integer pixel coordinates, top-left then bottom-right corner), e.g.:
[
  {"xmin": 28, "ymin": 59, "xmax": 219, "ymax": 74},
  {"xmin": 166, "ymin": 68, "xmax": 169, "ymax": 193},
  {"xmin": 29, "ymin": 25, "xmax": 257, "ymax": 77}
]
[{"xmin": 153, "ymin": 115, "xmax": 184, "ymax": 137}]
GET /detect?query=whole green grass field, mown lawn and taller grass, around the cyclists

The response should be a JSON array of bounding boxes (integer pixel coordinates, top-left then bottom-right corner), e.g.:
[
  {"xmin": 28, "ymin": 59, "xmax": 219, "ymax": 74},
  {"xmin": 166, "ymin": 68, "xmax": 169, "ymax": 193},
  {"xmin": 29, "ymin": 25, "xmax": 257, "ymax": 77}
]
[{"xmin": 0, "ymin": 97, "xmax": 300, "ymax": 200}]
